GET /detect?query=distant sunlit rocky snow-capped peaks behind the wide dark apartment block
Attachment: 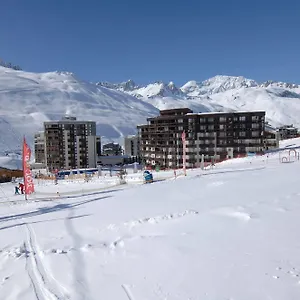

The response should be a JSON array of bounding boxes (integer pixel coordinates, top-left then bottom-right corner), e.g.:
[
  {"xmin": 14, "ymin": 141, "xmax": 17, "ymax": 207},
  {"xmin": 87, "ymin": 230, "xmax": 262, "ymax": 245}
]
[{"xmin": 101, "ymin": 75, "xmax": 300, "ymax": 127}]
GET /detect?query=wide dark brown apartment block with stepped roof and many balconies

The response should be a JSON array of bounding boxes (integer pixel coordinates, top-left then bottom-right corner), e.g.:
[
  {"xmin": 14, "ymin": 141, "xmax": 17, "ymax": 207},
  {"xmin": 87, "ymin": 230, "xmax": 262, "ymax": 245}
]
[{"xmin": 138, "ymin": 108, "xmax": 275, "ymax": 168}]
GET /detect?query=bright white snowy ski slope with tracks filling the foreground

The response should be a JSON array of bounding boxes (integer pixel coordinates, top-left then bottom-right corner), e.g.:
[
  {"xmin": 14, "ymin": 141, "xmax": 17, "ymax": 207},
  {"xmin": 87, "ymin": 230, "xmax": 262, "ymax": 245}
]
[{"xmin": 0, "ymin": 139, "xmax": 300, "ymax": 300}]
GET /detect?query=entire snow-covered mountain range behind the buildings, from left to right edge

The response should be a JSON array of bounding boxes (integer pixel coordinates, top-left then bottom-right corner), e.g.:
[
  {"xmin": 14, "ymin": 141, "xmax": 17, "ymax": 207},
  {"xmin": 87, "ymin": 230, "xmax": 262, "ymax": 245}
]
[{"xmin": 0, "ymin": 67, "xmax": 300, "ymax": 161}]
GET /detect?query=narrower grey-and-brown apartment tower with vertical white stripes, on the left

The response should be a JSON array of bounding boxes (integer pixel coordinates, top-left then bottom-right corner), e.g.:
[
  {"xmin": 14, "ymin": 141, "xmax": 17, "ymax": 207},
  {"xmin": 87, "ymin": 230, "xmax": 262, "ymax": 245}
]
[{"xmin": 44, "ymin": 116, "xmax": 100, "ymax": 171}]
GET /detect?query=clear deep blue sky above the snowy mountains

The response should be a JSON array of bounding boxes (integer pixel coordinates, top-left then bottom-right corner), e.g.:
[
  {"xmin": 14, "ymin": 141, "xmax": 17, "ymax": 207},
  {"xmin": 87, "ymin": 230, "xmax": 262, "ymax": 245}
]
[{"xmin": 0, "ymin": 0, "xmax": 300, "ymax": 85}]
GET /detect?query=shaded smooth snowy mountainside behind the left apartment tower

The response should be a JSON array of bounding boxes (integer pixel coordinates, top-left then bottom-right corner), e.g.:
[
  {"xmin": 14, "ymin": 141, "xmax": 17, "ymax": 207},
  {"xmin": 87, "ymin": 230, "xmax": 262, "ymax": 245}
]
[{"xmin": 0, "ymin": 67, "xmax": 157, "ymax": 151}]
